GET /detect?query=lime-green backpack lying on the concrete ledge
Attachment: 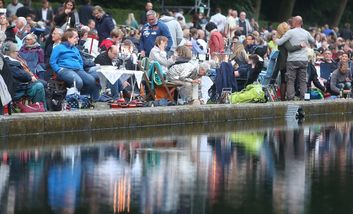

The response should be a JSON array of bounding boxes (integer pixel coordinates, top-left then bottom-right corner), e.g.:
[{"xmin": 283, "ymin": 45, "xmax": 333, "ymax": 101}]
[{"xmin": 230, "ymin": 84, "xmax": 266, "ymax": 104}]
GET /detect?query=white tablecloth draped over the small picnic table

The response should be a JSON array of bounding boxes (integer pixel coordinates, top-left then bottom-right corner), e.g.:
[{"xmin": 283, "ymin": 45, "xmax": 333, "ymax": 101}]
[{"xmin": 97, "ymin": 65, "xmax": 143, "ymax": 87}]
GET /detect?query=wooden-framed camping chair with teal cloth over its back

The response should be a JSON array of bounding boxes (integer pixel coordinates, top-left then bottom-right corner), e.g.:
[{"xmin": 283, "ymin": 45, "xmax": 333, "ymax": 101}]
[{"xmin": 147, "ymin": 61, "xmax": 180, "ymax": 101}]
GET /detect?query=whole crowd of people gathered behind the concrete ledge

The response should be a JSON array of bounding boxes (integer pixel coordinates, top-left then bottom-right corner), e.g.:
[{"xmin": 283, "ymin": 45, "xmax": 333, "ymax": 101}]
[{"xmin": 0, "ymin": 0, "xmax": 353, "ymax": 113}]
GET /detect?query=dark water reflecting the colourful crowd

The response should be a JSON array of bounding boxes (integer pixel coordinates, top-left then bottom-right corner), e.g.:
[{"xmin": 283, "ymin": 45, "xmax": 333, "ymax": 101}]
[{"xmin": 0, "ymin": 120, "xmax": 353, "ymax": 214}]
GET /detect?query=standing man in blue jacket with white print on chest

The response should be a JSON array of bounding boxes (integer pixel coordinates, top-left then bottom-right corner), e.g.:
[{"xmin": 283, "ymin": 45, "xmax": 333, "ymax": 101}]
[{"xmin": 140, "ymin": 10, "xmax": 173, "ymax": 57}]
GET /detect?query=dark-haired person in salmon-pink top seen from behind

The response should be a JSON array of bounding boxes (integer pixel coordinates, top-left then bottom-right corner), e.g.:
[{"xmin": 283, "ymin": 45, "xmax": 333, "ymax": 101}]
[{"xmin": 206, "ymin": 22, "xmax": 224, "ymax": 55}]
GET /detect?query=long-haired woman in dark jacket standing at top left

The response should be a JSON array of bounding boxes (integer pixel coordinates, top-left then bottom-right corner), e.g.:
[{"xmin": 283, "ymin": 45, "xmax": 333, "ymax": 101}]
[{"xmin": 54, "ymin": 0, "xmax": 80, "ymax": 31}]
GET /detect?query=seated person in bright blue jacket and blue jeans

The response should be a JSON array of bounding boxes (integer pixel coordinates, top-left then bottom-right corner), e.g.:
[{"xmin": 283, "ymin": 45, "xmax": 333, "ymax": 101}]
[{"xmin": 50, "ymin": 28, "xmax": 99, "ymax": 101}]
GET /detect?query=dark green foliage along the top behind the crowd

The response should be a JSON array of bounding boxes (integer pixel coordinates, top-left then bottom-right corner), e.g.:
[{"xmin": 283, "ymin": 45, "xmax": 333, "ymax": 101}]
[{"xmin": 32, "ymin": 0, "xmax": 353, "ymax": 26}]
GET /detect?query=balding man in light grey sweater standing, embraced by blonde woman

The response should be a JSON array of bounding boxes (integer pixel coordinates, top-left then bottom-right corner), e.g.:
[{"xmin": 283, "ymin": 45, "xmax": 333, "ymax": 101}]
[{"xmin": 275, "ymin": 16, "xmax": 315, "ymax": 100}]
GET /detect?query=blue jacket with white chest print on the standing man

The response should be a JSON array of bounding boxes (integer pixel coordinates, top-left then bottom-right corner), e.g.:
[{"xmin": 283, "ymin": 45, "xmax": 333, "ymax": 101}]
[{"xmin": 140, "ymin": 21, "xmax": 173, "ymax": 56}]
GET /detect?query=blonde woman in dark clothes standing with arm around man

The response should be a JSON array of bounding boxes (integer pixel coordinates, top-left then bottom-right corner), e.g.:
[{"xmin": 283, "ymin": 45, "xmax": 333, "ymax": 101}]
[{"xmin": 272, "ymin": 22, "xmax": 304, "ymax": 101}]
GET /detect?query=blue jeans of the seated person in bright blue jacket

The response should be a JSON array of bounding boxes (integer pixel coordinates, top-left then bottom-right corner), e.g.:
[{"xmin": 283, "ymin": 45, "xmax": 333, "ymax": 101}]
[{"xmin": 58, "ymin": 68, "xmax": 99, "ymax": 101}]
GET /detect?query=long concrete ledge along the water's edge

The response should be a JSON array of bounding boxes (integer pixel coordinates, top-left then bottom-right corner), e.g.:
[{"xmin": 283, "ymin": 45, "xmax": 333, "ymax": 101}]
[{"xmin": 0, "ymin": 99, "xmax": 353, "ymax": 136}]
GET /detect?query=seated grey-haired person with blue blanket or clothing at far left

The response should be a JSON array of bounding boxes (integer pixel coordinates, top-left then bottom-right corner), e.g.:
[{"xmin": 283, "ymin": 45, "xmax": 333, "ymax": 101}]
[{"xmin": 19, "ymin": 33, "xmax": 45, "ymax": 79}]
